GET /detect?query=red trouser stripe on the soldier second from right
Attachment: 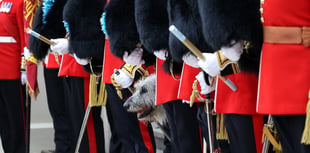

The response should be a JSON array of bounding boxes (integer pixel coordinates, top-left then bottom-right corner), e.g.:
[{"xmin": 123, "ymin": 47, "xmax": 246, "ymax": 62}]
[{"xmin": 252, "ymin": 115, "xmax": 264, "ymax": 153}]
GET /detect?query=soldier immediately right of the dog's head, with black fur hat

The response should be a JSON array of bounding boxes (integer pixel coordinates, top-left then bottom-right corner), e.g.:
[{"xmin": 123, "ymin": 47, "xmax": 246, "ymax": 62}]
[{"xmin": 135, "ymin": 0, "xmax": 203, "ymax": 153}]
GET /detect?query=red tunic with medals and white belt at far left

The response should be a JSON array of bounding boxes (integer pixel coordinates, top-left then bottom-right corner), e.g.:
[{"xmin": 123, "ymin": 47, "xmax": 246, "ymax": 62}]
[{"xmin": 0, "ymin": 0, "xmax": 25, "ymax": 79}]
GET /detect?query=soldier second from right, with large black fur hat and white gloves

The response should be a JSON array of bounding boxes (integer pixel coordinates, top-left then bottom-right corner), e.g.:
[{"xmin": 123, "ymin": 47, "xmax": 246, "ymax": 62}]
[{"xmin": 198, "ymin": 0, "xmax": 263, "ymax": 153}]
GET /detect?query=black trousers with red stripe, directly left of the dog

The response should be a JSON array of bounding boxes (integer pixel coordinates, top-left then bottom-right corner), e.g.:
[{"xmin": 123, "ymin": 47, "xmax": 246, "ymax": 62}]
[{"xmin": 106, "ymin": 84, "xmax": 155, "ymax": 153}]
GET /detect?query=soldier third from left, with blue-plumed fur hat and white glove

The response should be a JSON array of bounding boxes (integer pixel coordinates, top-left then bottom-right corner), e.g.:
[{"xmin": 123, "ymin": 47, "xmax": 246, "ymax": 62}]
[{"xmin": 51, "ymin": 0, "xmax": 105, "ymax": 153}]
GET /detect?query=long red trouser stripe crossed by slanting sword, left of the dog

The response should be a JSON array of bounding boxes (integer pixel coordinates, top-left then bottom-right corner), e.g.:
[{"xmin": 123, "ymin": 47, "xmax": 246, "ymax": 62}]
[{"xmin": 84, "ymin": 77, "xmax": 97, "ymax": 153}]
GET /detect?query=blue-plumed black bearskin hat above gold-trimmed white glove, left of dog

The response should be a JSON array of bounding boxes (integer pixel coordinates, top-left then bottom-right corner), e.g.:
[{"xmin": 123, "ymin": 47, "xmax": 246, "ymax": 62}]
[{"xmin": 105, "ymin": 0, "xmax": 156, "ymax": 66}]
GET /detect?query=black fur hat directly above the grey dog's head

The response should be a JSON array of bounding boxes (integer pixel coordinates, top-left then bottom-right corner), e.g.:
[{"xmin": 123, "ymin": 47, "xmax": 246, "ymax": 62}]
[{"xmin": 135, "ymin": 0, "xmax": 169, "ymax": 53}]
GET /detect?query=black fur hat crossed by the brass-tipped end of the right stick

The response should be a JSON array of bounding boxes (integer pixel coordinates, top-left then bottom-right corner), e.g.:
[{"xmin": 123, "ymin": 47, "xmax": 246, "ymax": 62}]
[{"xmin": 168, "ymin": 0, "xmax": 211, "ymax": 62}]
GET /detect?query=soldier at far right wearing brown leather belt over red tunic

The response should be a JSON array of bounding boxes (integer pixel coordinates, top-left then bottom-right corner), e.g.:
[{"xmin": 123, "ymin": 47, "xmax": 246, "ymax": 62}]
[{"xmin": 257, "ymin": 0, "xmax": 310, "ymax": 153}]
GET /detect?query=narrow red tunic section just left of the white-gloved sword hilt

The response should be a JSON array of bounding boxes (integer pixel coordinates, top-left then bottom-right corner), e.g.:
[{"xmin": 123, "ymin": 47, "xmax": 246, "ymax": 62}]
[{"xmin": 178, "ymin": 64, "xmax": 204, "ymax": 102}]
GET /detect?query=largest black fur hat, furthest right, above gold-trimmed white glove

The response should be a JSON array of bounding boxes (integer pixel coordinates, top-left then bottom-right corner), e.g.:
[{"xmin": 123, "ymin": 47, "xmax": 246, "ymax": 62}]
[{"xmin": 198, "ymin": 0, "xmax": 262, "ymax": 73}]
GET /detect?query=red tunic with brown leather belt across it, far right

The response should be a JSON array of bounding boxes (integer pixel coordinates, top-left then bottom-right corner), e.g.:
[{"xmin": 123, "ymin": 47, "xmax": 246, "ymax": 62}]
[{"xmin": 257, "ymin": 0, "xmax": 310, "ymax": 115}]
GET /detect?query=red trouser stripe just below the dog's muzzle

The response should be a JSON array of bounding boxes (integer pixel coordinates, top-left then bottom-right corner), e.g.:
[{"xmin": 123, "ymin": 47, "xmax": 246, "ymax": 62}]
[{"xmin": 139, "ymin": 121, "xmax": 154, "ymax": 153}]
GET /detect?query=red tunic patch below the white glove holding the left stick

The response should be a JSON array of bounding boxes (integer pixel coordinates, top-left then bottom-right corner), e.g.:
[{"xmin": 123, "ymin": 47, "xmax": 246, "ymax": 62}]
[{"xmin": 58, "ymin": 54, "xmax": 89, "ymax": 77}]
